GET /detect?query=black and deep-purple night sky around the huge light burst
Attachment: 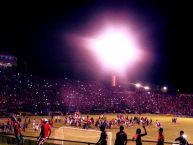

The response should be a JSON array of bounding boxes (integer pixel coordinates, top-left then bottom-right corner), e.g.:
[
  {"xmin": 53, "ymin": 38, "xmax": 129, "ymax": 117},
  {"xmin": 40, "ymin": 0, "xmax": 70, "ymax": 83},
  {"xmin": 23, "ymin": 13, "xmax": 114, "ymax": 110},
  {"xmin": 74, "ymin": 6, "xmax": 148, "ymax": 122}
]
[{"xmin": 0, "ymin": 0, "xmax": 193, "ymax": 92}]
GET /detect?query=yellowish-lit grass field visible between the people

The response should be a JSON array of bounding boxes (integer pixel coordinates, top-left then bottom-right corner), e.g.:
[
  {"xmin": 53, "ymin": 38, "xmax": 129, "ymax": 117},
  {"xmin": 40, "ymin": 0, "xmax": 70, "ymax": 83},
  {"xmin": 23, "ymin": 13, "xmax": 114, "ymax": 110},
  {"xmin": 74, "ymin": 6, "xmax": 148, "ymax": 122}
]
[{"xmin": 1, "ymin": 114, "xmax": 193, "ymax": 145}]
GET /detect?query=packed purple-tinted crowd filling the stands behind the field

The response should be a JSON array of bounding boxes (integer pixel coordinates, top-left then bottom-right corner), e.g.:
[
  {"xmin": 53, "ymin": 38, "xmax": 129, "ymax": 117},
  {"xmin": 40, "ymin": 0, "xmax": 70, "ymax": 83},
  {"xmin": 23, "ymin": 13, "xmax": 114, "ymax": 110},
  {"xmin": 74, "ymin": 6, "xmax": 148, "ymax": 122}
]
[{"xmin": 0, "ymin": 68, "xmax": 193, "ymax": 116}]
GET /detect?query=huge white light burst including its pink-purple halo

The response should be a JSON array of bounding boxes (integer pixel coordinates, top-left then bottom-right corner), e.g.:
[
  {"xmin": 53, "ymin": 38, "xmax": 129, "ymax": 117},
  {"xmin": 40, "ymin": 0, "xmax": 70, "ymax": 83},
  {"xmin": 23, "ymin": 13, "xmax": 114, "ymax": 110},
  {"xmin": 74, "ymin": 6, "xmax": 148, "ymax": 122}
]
[{"xmin": 66, "ymin": 11, "xmax": 154, "ymax": 78}]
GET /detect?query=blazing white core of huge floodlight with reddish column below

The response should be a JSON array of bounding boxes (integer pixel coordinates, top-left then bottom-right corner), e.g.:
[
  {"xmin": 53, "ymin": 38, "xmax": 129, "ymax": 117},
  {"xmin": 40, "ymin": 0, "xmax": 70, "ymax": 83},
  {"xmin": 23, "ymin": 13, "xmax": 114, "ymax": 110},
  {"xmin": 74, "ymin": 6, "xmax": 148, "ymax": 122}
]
[{"xmin": 90, "ymin": 26, "xmax": 140, "ymax": 86}]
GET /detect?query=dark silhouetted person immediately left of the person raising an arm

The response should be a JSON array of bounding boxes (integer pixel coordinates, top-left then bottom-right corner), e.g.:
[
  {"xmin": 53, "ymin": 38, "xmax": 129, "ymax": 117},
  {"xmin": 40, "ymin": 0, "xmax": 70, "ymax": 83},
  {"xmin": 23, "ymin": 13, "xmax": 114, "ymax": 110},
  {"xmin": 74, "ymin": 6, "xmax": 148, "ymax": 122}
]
[{"xmin": 115, "ymin": 125, "xmax": 127, "ymax": 145}]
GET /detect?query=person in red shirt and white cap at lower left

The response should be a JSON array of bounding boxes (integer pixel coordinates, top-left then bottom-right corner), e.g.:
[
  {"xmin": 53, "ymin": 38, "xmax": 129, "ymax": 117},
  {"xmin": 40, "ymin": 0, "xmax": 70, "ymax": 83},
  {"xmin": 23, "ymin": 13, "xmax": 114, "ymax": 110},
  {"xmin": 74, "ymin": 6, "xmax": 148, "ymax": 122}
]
[{"xmin": 37, "ymin": 118, "xmax": 51, "ymax": 145}]
